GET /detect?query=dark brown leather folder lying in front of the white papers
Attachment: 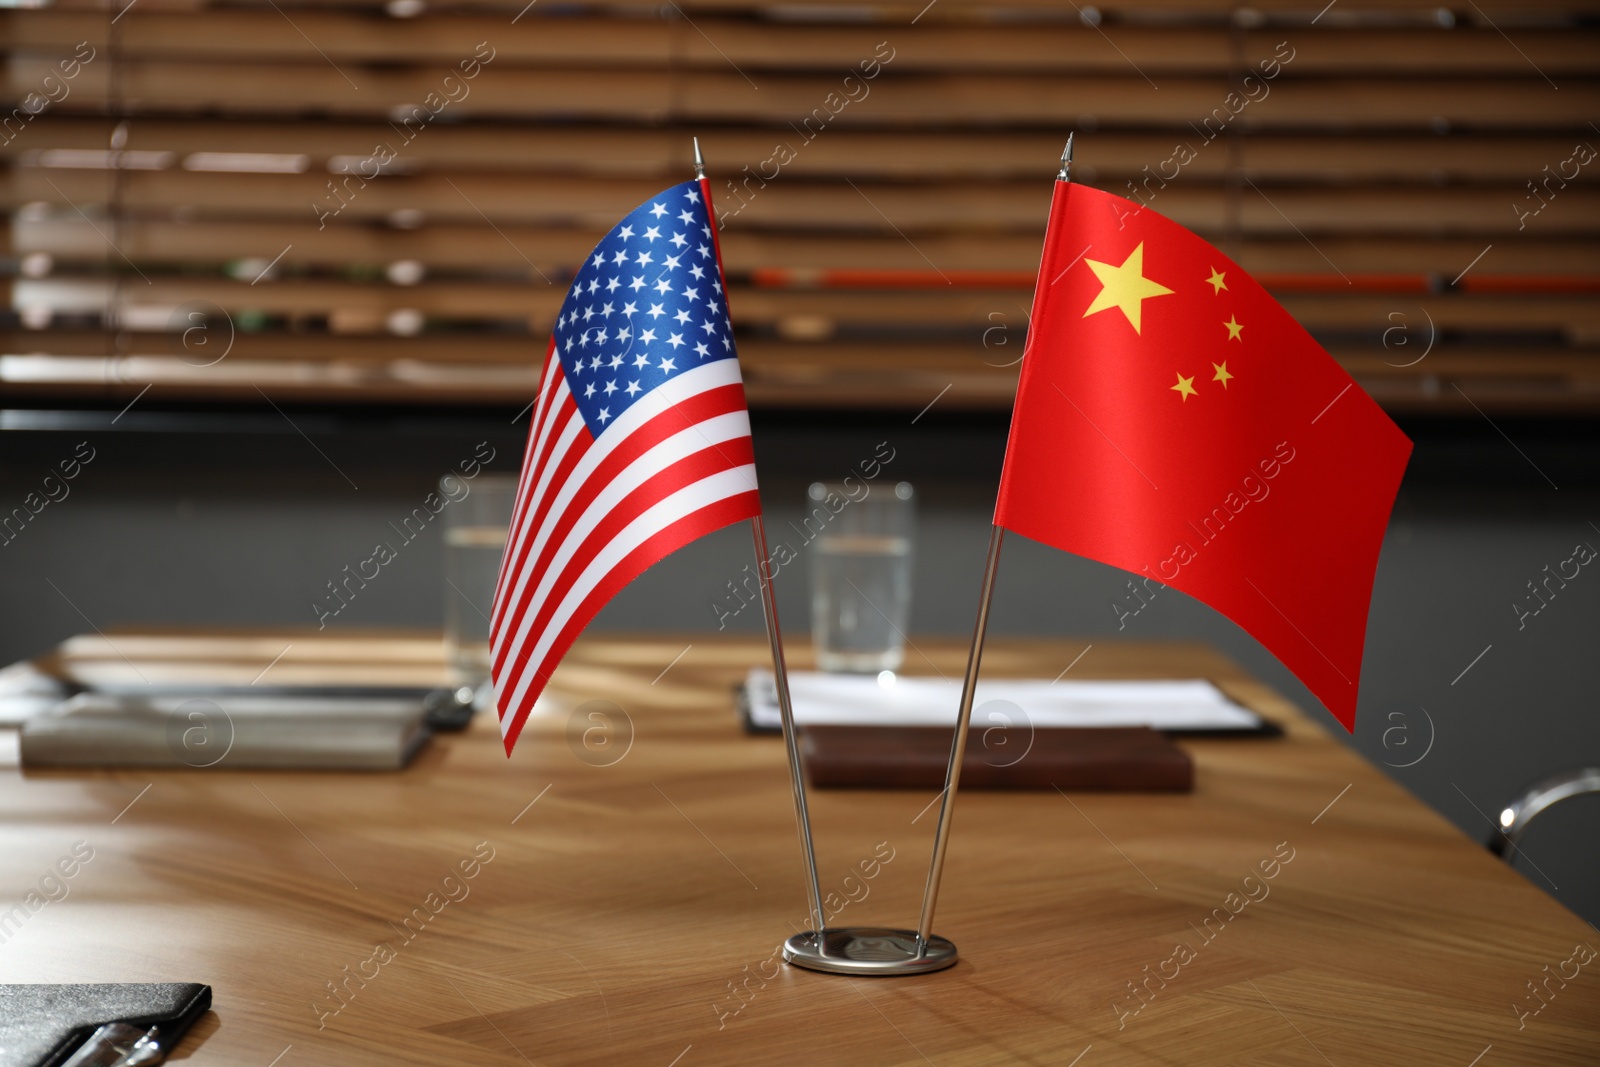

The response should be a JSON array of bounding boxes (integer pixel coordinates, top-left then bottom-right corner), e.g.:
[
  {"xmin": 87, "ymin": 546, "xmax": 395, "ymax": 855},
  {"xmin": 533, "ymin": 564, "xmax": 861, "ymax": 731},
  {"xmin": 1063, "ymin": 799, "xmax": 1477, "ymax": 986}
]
[{"xmin": 800, "ymin": 726, "xmax": 1194, "ymax": 793}]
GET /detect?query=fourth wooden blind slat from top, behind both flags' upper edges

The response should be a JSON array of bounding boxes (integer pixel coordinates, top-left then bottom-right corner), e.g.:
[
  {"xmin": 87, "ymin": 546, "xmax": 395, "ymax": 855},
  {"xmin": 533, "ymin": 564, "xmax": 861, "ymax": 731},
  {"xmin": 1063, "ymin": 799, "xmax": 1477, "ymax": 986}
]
[{"xmin": 9, "ymin": 168, "xmax": 1600, "ymax": 238}]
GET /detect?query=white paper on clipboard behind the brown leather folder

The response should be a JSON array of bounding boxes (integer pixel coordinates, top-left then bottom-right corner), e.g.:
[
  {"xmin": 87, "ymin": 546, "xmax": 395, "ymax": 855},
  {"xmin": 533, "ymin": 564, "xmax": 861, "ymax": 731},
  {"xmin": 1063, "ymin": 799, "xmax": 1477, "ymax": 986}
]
[{"xmin": 744, "ymin": 669, "xmax": 1275, "ymax": 734}]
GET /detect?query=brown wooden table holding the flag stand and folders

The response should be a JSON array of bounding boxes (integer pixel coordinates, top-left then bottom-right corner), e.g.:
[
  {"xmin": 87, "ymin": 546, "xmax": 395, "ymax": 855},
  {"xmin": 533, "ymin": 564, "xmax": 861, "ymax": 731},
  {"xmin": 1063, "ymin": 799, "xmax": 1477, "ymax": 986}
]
[{"xmin": 0, "ymin": 633, "xmax": 1600, "ymax": 1067}]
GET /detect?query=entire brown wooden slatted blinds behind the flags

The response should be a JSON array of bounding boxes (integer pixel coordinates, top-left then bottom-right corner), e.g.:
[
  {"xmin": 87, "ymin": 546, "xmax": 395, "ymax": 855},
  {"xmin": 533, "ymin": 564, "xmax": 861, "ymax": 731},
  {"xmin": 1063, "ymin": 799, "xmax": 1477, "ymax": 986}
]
[{"xmin": 0, "ymin": 0, "xmax": 1600, "ymax": 411}]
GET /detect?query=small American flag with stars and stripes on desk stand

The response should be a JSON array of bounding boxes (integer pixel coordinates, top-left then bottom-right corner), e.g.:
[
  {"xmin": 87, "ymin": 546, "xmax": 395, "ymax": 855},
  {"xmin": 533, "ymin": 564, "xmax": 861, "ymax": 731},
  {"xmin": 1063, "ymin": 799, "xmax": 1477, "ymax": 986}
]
[{"xmin": 490, "ymin": 181, "xmax": 760, "ymax": 755}]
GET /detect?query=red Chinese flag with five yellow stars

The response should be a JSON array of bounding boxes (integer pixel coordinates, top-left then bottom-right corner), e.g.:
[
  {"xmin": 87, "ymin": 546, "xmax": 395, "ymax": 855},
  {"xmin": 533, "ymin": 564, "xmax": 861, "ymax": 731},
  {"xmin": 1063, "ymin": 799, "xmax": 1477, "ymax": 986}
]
[{"xmin": 995, "ymin": 182, "xmax": 1411, "ymax": 729}]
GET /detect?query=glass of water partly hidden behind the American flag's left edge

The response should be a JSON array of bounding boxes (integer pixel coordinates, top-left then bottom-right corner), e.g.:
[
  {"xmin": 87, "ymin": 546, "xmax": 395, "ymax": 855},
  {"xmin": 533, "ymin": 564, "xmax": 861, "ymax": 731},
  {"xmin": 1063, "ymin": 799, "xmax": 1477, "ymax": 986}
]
[{"xmin": 438, "ymin": 474, "xmax": 517, "ymax": 686}]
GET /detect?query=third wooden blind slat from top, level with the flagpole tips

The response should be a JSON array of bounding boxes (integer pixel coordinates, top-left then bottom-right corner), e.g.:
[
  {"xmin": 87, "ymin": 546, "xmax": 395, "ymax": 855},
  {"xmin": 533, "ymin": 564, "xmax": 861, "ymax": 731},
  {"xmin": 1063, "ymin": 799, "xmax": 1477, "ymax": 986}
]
[{"xmin": 0, "ymin": 114, "xmax": 1595, "ymax": 190}]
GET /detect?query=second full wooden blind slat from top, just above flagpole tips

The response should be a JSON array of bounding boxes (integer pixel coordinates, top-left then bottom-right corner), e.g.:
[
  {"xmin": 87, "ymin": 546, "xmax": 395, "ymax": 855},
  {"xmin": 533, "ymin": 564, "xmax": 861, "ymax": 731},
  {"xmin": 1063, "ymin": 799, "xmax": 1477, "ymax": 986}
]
[{"xmin": 10, "ymin": 56, "xmax": 1600, "ymax": 130}]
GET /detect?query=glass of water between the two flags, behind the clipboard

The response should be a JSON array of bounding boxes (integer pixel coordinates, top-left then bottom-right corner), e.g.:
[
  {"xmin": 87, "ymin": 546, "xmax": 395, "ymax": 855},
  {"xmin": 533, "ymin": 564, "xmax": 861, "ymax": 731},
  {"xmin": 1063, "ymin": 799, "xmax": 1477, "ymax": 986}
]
[{"xmin": 802, "ymin": 482, "xmax": 917, "ymax": 673}]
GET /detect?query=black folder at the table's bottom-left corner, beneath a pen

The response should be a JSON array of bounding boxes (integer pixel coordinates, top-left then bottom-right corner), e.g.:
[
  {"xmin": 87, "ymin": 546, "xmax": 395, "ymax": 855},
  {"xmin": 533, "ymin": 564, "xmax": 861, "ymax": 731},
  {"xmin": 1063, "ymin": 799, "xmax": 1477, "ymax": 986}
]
[{"xmin": 0, "ymin": 982, "xmax": 211, "ymax": 1067}]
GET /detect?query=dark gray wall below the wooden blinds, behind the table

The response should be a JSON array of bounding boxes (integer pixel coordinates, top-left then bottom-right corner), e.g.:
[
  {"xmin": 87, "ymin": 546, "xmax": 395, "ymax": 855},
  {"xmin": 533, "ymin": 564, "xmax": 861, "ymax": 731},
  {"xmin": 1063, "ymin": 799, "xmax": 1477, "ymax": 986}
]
[{"xmin": 0, "ymin": 410, "xmax": 1600, "ymax": 921}]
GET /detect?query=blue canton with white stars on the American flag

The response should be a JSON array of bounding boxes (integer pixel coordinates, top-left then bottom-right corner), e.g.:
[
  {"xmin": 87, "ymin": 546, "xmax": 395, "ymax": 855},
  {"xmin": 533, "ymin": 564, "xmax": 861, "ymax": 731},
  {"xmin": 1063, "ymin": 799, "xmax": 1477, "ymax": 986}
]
[{"xmin": 555, "ymin": 182, "xmax": 736, "ymax": 437}]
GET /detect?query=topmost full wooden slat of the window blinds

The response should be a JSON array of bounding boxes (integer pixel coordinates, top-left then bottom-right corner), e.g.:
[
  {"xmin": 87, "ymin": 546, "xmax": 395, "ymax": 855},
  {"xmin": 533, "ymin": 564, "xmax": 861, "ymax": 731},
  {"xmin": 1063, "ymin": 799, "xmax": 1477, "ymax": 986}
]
[{"xmin": 10, "ymin": 8, "xmax": 1594, "ymax": 78}]
